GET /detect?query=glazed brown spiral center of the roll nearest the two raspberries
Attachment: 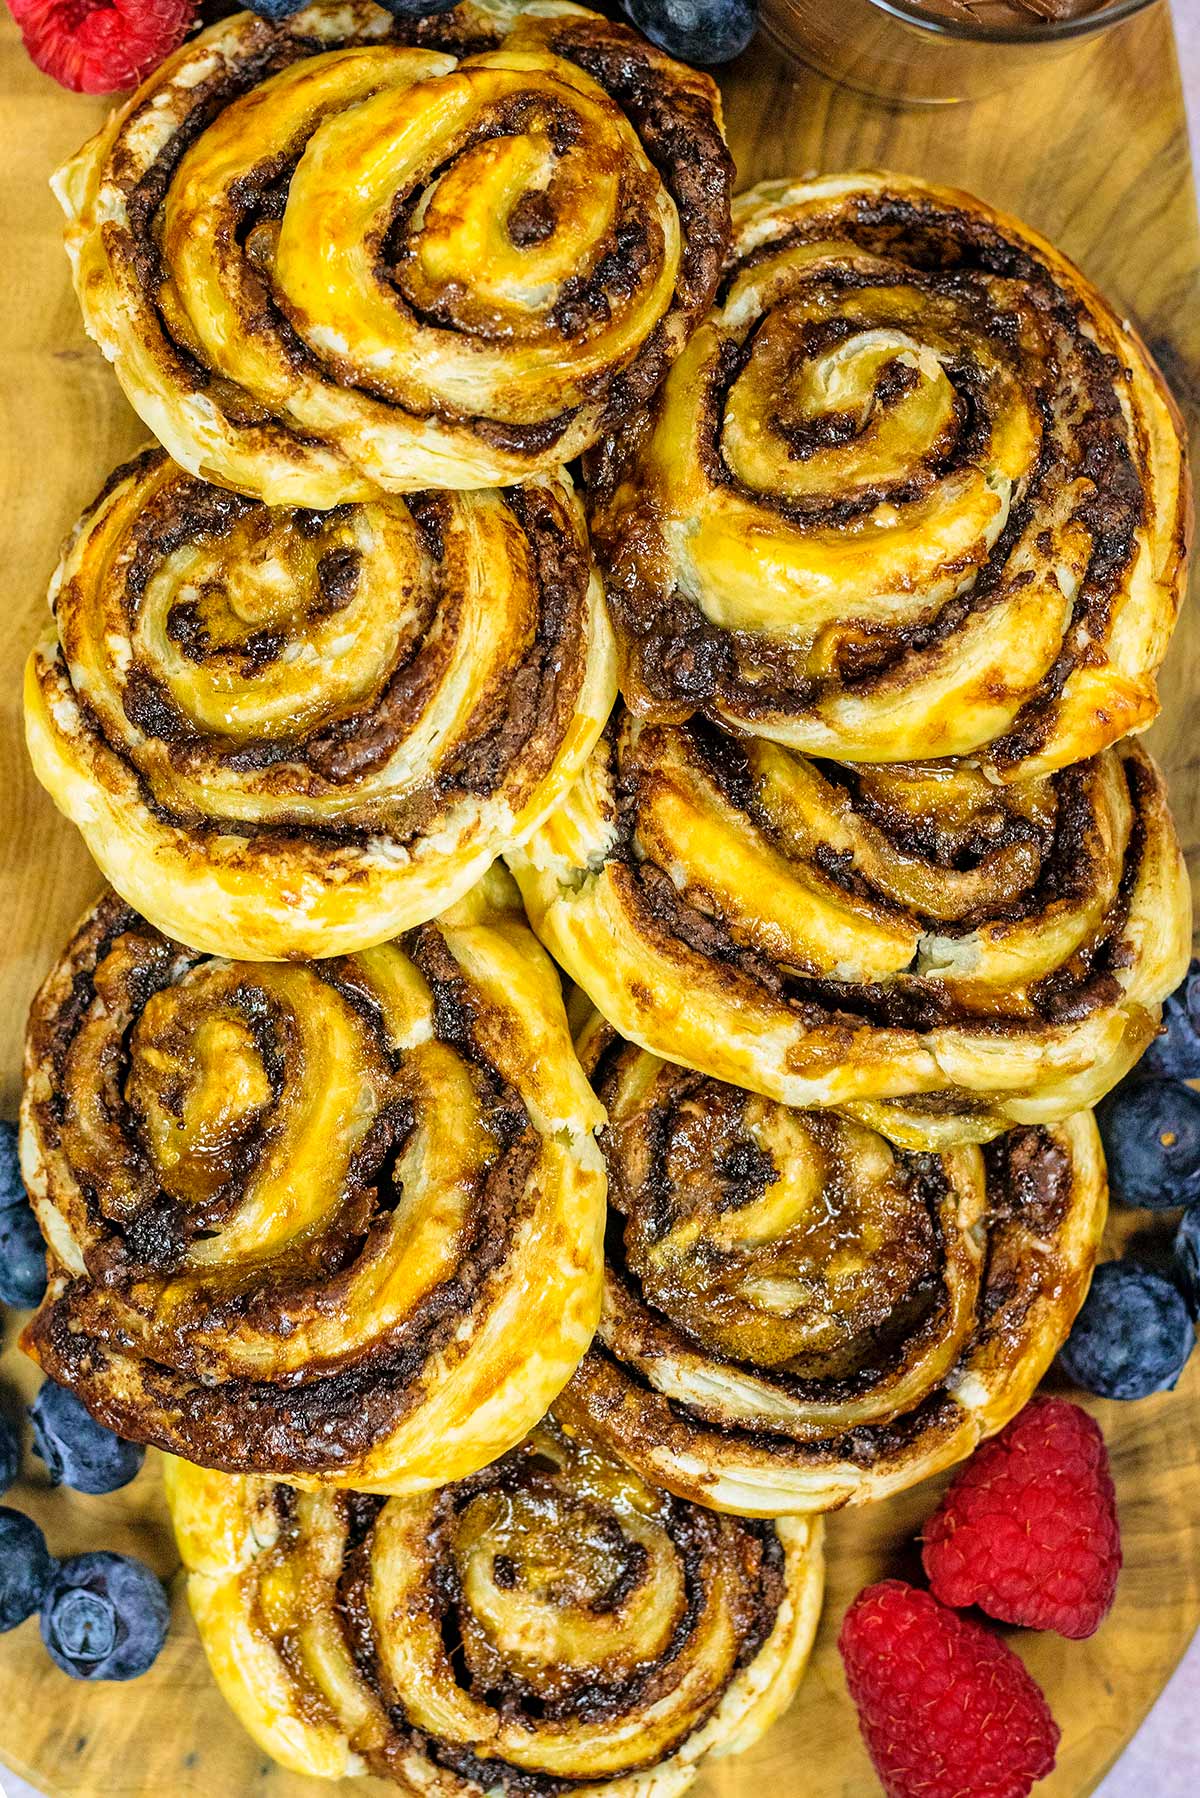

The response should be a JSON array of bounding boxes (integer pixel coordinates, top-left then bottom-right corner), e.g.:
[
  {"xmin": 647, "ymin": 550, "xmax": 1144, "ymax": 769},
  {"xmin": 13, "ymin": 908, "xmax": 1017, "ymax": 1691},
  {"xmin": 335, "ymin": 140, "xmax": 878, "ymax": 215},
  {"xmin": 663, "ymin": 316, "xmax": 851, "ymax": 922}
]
[{"xmin": 608, "ymin": 1066, "xmax": 939, "ymax": 1377}]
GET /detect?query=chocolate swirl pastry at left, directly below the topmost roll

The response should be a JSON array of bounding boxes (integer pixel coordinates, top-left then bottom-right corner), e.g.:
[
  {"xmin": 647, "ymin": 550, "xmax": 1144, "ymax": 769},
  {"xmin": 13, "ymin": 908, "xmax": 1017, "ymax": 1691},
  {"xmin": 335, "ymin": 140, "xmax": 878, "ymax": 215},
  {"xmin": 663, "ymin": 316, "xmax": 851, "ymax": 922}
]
[{"xmin": 25, "ymin": 451, "xmax": 615, "ymax": 960}]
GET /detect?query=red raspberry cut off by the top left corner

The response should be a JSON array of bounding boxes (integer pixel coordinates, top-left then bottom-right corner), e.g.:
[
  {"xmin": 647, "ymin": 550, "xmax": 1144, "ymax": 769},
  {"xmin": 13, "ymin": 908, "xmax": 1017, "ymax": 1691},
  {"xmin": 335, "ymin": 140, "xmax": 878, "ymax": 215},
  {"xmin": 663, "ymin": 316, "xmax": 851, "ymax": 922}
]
[{"xmin": 9, "ymin": 0, "xmax": 196, "ymax": 93}]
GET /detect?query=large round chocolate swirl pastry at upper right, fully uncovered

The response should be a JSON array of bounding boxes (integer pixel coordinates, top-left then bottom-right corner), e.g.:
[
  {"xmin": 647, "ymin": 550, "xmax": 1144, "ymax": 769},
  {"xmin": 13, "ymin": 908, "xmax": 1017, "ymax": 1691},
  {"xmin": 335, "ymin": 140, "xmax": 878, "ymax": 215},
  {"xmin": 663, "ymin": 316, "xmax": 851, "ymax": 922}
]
[{"xmin": 592, "ymin": 174, "xmax": 1191, "ymax": 779}]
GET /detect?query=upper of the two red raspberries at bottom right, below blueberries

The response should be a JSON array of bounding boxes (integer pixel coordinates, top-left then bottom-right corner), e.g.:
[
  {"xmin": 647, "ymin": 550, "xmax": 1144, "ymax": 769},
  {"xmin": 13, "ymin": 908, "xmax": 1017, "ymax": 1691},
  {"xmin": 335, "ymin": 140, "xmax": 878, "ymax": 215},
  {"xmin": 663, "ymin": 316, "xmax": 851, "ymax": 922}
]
[{"xmin": 923, "ymin": 1399, "xmax": 1121, "ymax": 1640}]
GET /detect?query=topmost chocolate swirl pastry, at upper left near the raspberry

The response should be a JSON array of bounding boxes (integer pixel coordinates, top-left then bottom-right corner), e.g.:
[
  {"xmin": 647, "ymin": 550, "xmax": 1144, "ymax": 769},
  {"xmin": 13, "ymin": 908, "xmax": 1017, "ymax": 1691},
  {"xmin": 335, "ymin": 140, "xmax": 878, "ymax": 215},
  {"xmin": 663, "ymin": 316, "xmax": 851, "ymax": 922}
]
[{"xmin": 54, "ymin": 0, "xmax": 732, "ymax": 507}]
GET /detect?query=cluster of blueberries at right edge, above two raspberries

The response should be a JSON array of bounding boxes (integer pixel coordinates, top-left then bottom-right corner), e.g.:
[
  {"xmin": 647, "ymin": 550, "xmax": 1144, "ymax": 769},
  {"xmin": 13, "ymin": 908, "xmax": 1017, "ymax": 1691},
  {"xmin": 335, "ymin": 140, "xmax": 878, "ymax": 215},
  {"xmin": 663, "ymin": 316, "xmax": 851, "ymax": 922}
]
[{"xmin": 1060, "ymin": 962, "xmax": 1200, "ymax": 1399}]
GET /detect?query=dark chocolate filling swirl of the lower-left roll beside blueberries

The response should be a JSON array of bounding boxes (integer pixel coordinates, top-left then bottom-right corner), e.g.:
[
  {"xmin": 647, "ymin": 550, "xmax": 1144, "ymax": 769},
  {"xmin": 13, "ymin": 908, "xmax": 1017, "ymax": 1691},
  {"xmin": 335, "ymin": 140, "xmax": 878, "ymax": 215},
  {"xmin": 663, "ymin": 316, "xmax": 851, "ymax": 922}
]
[{"xmin": 29, "ymin": 895, "xmax": 540, "ymax": 1474}]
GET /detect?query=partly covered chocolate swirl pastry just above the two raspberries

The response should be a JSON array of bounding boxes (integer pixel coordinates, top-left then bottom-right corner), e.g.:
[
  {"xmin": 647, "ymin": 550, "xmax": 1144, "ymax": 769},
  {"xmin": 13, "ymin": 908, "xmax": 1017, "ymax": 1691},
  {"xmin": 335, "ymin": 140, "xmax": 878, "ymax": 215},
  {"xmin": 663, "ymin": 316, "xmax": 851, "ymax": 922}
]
[{"xmin": 558, "ymin": 1014, "xmax": 1106, "ymax": 1516}]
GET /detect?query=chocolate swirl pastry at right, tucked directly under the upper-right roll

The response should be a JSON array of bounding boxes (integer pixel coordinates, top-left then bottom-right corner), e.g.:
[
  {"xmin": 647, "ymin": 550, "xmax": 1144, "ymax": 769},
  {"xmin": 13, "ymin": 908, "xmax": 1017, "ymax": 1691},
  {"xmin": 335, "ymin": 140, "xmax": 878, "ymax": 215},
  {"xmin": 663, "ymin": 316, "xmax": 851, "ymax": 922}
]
[{"xmin": 509, "ymin": 710, "xmax": 1191, "ymax": 1147}]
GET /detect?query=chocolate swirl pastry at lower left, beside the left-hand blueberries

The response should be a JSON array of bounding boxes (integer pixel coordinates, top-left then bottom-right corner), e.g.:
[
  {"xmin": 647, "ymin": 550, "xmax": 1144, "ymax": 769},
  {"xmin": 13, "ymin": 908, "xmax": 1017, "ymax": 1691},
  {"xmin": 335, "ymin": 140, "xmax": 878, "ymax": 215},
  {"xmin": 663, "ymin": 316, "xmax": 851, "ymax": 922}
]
[{"xmin": 22, "ymin": 870, "xmax": 604, "ymax": 1492}]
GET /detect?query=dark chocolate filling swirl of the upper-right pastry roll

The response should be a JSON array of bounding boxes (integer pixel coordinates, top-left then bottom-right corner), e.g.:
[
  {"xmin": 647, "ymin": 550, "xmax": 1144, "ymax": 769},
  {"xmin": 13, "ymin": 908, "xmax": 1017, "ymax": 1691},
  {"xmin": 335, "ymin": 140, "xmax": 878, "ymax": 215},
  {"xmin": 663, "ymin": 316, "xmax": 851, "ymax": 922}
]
[{"xmin": 590, "ymin": 182, "xmax": 1144, "ymax": 744}]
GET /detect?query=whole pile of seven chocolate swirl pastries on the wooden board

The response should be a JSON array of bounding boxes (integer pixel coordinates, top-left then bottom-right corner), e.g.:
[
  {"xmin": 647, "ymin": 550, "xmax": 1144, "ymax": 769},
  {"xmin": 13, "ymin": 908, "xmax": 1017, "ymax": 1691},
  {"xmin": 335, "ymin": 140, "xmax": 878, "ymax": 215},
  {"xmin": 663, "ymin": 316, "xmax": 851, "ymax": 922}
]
[{"xmin": 22, "ymin": 0, "xmax": 1191, "ymax": 1798}]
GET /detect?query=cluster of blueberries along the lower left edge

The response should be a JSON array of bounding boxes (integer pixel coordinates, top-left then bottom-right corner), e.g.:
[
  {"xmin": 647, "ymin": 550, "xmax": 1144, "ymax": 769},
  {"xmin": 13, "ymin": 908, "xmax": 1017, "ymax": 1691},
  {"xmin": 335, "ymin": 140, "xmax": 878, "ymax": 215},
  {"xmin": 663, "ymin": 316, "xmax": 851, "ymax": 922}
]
[{"xmin": 0, "ymin": 1124, "xmax": 169, "ymax": 1679}]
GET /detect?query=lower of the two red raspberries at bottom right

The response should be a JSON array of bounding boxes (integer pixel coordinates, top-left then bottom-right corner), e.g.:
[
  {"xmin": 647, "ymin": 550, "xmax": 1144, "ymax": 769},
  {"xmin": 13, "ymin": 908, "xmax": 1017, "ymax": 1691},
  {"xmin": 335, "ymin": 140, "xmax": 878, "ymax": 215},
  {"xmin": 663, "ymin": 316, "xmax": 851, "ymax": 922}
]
[{"xmin": 838, "ymin": 1579, "xmax": 1058, "ymax": 1798}]
